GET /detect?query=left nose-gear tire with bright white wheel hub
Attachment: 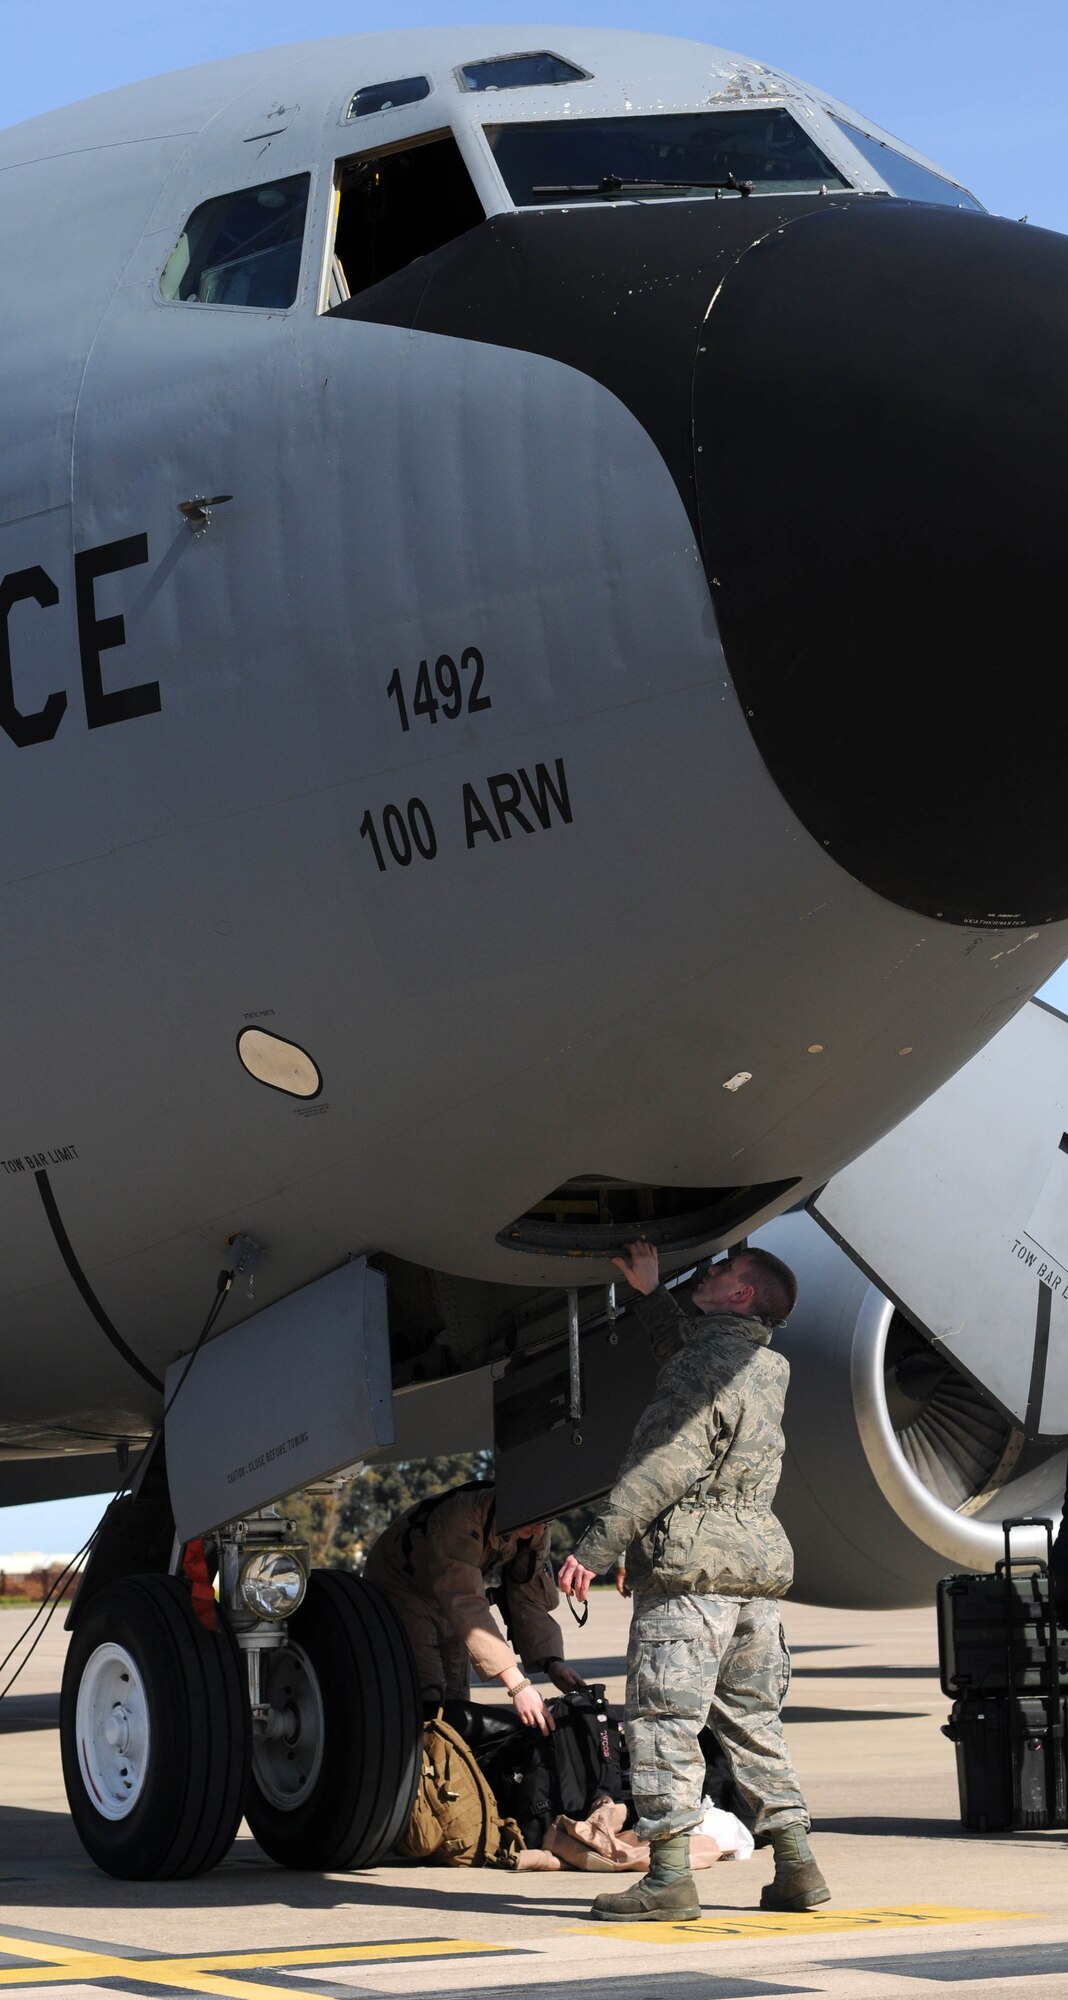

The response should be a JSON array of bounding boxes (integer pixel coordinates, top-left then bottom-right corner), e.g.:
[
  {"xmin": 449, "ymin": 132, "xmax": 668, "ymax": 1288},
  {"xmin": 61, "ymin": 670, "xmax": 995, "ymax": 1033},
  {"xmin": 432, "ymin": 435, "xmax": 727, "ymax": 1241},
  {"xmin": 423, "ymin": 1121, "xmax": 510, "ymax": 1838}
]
[{"xmin": 60, "ymin": 1576, "xmax": 250, "ymax": 1882}]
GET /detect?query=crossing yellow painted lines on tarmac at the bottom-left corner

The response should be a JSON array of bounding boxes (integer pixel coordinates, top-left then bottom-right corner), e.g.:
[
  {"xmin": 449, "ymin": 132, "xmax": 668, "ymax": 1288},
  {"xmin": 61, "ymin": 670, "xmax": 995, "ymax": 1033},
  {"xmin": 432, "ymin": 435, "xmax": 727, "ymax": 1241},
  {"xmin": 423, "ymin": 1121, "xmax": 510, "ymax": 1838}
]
[{"xmin": 0, "ymin": 1932, "xmax": 514, "ymax": 2000}]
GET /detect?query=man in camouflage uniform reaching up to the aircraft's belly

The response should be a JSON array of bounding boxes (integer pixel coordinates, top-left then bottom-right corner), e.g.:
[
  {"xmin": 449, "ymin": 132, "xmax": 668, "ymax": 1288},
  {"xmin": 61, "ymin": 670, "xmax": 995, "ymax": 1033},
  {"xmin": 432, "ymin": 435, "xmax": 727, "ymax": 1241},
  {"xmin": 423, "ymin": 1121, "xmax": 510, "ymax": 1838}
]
[{"xmin": 560, "ymin": 1244, "xmax": 830, "ymax": 1922}]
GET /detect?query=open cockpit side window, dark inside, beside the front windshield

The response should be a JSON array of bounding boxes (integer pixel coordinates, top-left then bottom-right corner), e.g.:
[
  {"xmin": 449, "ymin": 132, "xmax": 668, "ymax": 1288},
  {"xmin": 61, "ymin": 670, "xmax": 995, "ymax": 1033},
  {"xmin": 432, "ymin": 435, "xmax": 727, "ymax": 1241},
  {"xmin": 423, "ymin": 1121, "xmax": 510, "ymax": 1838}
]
[{"xmin": 328, "ymin": 132, "xmax": 486, "ymax": 306}]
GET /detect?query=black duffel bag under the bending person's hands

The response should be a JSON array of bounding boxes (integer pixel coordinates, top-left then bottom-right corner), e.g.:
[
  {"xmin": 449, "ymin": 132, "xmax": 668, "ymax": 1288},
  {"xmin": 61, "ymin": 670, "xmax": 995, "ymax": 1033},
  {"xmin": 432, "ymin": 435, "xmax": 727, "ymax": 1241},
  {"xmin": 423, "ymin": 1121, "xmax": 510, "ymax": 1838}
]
[{"xmin": 444, "ymin": 1684, "xmax": 628, "ymax": 1848}]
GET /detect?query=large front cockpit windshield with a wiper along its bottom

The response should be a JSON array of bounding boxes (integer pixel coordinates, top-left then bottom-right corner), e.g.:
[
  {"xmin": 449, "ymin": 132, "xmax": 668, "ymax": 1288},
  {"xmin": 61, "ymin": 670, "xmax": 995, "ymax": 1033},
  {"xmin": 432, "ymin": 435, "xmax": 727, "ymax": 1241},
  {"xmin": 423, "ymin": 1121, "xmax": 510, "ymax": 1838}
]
[{"xmin": 484, "ymin": 108, "xmax": 846, "ymax": 208}]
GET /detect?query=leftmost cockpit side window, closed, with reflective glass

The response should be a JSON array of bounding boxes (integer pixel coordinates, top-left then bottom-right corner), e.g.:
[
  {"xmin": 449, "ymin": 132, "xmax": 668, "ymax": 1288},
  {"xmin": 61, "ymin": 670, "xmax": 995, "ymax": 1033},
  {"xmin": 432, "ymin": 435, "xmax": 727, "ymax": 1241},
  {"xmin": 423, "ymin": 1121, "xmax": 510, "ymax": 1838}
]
[{"xmin": 160, "ymin": 174, "xmax": 310, "ymax": 308}]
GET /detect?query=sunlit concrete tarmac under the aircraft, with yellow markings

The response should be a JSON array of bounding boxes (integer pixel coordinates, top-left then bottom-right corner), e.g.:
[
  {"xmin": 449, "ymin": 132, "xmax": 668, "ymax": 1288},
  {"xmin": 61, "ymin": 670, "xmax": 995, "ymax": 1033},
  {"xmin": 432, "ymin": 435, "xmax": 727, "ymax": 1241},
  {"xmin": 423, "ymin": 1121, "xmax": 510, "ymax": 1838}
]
[{"xmin": 0, "ymin": 1592, "xmax": 1068, "ymax": 2000}]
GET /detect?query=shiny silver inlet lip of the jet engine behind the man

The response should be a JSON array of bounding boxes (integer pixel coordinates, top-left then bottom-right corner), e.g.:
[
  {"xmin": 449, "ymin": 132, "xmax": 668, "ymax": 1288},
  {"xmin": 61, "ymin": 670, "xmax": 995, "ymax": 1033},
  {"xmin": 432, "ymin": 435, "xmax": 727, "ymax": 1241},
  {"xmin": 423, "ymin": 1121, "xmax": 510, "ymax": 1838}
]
[{"xmin": 850, "ymin": 1284, "xmax": 1046, "ymax": 1570}]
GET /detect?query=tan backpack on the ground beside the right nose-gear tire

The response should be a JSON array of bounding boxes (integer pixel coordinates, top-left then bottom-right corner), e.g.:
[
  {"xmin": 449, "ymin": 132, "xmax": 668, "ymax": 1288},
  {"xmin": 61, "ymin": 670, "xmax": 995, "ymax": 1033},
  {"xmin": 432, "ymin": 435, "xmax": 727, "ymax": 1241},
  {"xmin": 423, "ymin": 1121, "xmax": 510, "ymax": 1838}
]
[{"xmin": 394, "ymin": 1714, "xmax": 524, "ymax": 1868}]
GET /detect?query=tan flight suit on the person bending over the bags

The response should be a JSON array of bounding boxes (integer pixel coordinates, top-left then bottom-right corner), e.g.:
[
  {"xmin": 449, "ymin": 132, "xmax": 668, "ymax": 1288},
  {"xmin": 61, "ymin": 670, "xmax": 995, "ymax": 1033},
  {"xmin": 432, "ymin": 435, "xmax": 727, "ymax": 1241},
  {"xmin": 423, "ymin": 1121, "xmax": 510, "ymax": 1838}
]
[{"xmin": 364, "ymin": 1486, "xmax": 564, "ymax": 1700}]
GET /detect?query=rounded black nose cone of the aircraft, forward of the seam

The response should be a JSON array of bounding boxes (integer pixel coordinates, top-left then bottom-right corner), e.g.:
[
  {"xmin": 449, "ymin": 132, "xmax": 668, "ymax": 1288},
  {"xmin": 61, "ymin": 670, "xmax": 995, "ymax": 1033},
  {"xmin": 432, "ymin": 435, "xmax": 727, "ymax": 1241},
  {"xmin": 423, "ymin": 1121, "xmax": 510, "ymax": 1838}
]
[{"xmin": 694, "ymin": 198, "xmax": 1068, "ymax": 924}]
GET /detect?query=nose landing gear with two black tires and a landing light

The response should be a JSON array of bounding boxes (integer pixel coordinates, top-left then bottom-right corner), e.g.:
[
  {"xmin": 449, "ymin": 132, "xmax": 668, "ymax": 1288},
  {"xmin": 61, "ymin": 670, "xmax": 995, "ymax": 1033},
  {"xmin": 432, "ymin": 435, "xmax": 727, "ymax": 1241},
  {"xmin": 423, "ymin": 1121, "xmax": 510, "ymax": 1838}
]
[{"xmin": 60, "ymin": 1516, "xmax": 422, "ymax": 1880}]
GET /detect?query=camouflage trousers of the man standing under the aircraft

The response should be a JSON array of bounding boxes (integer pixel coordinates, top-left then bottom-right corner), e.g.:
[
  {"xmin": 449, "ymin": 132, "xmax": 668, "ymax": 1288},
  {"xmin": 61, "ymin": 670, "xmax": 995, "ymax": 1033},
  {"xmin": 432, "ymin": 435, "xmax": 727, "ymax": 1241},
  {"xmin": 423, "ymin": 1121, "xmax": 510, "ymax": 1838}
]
[{"xmin": 626, "ymin": 1592, "xmax": 810, "ymax": 1840}]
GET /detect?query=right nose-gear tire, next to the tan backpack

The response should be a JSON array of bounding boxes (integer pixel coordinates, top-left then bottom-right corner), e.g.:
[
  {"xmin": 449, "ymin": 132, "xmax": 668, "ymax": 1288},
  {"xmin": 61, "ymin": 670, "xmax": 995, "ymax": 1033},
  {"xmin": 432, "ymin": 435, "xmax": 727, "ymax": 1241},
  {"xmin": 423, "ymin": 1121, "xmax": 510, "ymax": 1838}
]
[{"xmin": 244, "ymin": 1570, "xmax": 422, "ymax": 1872}]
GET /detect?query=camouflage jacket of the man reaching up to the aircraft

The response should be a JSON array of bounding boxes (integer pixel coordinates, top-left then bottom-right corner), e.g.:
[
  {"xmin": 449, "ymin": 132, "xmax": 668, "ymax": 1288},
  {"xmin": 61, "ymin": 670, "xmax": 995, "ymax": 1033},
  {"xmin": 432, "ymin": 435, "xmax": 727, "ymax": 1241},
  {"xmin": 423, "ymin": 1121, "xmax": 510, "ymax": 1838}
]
[{"xmin": 576, "ymin": 1286, "xmax": 794, "ymax": 1598}]
